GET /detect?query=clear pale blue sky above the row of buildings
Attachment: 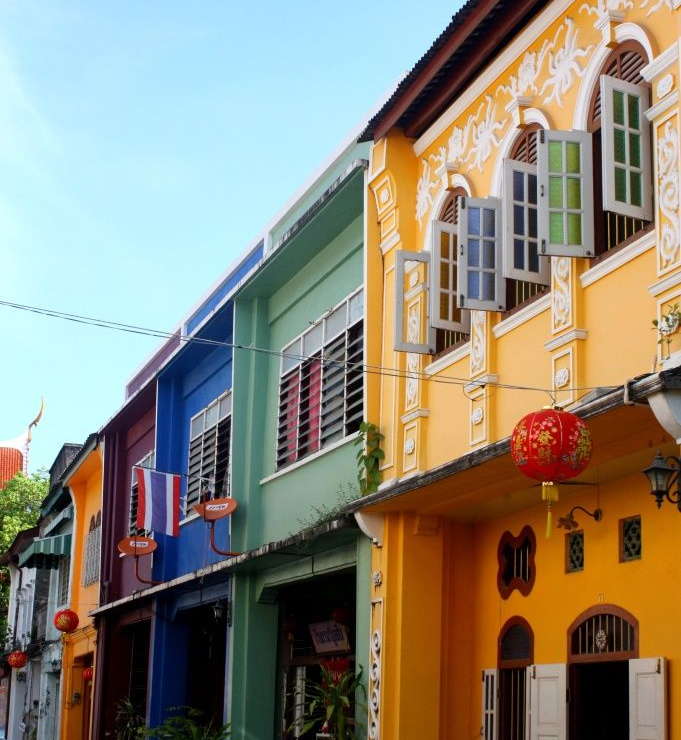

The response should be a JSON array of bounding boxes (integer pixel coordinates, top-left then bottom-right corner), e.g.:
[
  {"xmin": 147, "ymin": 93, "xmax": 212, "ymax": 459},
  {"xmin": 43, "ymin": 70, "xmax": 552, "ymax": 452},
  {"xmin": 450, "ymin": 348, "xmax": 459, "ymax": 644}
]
[{"xmin": 0, "ymin": 0, "xmax": 461, "ymax": 471}]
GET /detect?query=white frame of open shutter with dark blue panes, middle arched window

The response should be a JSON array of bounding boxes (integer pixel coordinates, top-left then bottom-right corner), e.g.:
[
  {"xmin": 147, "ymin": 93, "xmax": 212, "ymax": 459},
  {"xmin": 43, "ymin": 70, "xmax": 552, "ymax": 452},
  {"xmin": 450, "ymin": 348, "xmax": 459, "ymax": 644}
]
[{"xmin": 503, "ymin": 158, "xmax": 550, "ymax": 285}]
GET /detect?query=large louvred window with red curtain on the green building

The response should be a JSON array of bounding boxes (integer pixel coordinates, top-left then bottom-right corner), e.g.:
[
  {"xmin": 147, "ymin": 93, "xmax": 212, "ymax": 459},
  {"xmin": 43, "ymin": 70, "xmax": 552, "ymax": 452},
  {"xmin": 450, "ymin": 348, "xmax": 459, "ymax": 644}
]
[{"xmin": 277, "ymin": 291, "xmax": 364, "ymax": 468}]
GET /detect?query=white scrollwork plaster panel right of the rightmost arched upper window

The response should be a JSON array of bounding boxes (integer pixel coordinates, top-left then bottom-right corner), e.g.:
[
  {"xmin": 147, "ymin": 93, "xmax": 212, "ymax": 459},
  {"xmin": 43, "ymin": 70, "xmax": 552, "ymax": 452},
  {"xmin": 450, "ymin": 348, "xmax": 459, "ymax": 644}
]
[{"xmin": 657, "ymin": 121, "xmax": 679, "ymax": 268}]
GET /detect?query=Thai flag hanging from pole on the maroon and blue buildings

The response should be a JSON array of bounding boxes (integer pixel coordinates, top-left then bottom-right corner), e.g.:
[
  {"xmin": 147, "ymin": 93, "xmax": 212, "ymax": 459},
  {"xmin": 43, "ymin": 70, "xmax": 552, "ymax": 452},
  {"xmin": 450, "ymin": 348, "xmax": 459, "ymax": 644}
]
[{"xmin": 135, "ymin": 468, "xmax": 180, "ymax": 537}]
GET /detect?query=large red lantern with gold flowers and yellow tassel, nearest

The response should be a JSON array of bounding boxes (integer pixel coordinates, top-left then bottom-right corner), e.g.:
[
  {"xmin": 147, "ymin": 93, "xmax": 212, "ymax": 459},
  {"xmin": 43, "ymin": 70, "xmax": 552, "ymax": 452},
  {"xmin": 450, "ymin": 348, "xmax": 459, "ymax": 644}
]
[{"xmin": 511, "ymin": 407, "xmax": 593, "ymax": 537}]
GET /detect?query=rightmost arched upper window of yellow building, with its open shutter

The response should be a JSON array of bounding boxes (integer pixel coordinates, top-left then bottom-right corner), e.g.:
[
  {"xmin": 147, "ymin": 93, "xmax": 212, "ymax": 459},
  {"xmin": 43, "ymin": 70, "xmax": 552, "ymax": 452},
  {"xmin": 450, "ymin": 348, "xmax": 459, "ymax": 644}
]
[{"xmin": 588, "ymin": 41, "xmax": 652, "ymax": 256}]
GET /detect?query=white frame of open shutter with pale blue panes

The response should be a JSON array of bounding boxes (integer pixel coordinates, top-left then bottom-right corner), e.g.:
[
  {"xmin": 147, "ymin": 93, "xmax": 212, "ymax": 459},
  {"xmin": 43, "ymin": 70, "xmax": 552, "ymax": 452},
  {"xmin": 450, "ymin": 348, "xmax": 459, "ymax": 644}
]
[{"xmin": 457, "ymin": 197, "xmax": 506, "ymax": 311}]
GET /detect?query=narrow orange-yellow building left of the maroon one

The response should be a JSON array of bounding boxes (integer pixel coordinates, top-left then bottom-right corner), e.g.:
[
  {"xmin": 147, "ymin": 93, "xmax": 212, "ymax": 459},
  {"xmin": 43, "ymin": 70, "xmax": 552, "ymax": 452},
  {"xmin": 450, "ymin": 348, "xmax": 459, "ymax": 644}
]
[{"xmin": 60, "ymin": 434, "xmax": 102, "ymax": 740}]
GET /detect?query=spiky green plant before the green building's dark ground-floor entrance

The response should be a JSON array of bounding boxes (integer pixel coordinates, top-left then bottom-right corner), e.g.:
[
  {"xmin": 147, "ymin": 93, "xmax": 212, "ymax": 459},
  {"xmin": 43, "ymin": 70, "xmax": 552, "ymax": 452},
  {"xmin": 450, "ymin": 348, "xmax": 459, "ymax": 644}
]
[{"xmin": 289, "ymin": 665, "xmax": 364, "ymax": 740}]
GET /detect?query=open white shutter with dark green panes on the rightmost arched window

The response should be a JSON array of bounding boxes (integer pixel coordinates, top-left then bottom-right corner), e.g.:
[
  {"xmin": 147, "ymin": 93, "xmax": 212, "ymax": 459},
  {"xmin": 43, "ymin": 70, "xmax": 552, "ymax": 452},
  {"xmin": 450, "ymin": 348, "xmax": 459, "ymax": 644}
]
[{"xmin": 601, "ymin": 75, "xmax": 653, "ymax": 221}]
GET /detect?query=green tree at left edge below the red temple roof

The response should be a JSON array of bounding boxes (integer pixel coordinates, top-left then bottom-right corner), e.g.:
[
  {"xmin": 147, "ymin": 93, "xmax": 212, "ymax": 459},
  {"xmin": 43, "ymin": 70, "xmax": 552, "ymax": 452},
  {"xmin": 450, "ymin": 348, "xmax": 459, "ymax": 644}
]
[{"xmin": 0, "ymin": 469, "xmax": 50, "ymax": 647}]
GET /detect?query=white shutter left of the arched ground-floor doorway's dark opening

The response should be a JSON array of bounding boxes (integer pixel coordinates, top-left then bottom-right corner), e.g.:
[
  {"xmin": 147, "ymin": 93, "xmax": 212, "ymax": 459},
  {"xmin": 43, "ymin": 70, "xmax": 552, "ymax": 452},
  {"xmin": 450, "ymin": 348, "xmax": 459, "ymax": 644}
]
[{"xmin": 526, "ymin": 663, "xmax": 567, "ymax": 740}]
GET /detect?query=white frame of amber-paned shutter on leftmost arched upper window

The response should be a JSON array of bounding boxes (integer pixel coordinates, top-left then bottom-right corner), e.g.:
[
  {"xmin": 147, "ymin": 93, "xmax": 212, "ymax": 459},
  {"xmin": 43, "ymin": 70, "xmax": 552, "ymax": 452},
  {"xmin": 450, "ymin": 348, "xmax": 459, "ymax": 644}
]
[{"xmin": 428, "ymin": 220, "xmax": 471, "ymax": 334}]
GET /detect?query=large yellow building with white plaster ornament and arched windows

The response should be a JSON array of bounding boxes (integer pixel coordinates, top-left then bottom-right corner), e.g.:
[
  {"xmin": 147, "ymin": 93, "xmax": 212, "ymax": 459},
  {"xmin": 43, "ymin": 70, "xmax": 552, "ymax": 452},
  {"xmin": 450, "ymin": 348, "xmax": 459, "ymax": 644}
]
[{"xmin": 357, "ymin": 0, "xmax": 681, "ymax": 740}]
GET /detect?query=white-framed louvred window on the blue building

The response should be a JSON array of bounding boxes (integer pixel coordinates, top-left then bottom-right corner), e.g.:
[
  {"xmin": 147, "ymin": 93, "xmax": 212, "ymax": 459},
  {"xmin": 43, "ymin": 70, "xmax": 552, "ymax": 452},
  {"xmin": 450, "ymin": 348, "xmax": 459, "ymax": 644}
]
[{"xmin": 185, "ymin": 393, "xmax": 232, "ymax": 513}]
